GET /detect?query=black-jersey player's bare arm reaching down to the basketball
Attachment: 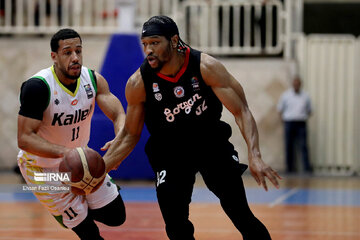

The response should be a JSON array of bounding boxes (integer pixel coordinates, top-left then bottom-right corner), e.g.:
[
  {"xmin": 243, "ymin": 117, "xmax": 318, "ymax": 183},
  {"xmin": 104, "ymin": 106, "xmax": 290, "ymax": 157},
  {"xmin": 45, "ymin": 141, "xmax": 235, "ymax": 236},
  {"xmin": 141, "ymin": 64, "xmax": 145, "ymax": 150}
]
[{"xmin": 103, "ymin": 69, "xmax": 146, "ymax": 172}]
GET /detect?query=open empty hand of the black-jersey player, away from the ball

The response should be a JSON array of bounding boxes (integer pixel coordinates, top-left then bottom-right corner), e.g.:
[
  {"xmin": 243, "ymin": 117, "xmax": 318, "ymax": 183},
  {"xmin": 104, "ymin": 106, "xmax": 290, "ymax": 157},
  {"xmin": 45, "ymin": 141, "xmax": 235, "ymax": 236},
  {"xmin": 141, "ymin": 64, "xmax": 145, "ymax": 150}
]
[{"xmin": 249, "ymin": 157, "xmax": 281, "ymax": 191}]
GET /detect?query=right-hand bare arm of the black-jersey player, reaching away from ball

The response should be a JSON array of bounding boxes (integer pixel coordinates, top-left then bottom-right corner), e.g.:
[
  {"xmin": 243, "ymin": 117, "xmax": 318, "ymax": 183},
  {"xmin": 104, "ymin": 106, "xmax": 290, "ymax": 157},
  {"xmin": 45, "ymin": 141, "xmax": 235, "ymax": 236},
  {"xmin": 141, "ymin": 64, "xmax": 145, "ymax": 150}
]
[{"xmin": 200, "ymin": 53, "xmax": 281, "ymax": 190}]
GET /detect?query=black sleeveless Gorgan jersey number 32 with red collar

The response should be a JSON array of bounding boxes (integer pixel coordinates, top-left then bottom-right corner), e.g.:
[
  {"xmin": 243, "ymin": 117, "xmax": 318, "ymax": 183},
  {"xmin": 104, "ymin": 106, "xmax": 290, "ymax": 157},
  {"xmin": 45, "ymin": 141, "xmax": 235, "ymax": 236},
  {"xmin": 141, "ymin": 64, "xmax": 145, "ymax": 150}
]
[{"xmin": 140, "ymin": 48, "xmax": 231, "ymax": 141}]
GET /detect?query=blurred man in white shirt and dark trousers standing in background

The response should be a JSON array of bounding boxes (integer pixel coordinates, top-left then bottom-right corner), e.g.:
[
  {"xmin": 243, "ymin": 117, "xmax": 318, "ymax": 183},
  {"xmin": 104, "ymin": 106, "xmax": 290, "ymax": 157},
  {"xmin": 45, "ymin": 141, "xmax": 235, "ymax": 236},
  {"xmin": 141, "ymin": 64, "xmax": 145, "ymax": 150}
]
[{"xmin": 277, "ymin": 76, "xmax": 312, "ymax": 173}]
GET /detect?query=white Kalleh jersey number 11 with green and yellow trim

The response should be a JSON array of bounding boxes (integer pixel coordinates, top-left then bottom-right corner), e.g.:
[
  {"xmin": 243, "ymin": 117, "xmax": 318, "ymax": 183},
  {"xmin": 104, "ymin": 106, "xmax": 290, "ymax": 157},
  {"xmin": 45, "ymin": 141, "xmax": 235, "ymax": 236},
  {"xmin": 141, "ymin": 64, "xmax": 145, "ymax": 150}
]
[{"xmin": 18, "ymin": 66, "xmax": 97, "ymax": 168}]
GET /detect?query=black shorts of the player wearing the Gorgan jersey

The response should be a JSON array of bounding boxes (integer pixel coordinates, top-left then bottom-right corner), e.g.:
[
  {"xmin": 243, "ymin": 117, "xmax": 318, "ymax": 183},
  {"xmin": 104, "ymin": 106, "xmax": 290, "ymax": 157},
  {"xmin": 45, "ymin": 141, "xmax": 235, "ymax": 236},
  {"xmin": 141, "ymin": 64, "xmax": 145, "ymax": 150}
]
[{"xmin": 145, "ymin": 132, "xmax": 247, "ymax": 188}]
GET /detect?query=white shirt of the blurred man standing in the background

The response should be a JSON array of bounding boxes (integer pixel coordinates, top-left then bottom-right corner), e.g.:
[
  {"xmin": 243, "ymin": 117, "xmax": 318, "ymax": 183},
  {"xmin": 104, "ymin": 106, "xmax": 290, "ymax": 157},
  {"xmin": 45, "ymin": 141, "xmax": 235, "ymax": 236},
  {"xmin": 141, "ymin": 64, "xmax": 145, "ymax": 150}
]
[{"xmin": 277, "ymin": 89, "xmax": 312, "ymax": 121}]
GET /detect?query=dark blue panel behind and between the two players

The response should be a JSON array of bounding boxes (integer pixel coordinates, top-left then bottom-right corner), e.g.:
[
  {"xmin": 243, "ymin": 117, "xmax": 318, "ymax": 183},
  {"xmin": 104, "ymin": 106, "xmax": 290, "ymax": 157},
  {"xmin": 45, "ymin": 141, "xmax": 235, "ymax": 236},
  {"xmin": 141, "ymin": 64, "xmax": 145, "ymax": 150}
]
[{"xmin": 89, "ymin": 34, "xmax": 154, "ymax": 179}]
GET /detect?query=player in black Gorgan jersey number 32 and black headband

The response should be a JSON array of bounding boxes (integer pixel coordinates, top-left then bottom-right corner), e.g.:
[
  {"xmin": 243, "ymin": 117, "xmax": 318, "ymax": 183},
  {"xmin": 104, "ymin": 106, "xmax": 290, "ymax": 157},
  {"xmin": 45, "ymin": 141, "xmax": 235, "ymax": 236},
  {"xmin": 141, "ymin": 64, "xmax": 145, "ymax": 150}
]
[{"xmin": 104, "ymin": 16, "xmax": 280, "ymax": 240}]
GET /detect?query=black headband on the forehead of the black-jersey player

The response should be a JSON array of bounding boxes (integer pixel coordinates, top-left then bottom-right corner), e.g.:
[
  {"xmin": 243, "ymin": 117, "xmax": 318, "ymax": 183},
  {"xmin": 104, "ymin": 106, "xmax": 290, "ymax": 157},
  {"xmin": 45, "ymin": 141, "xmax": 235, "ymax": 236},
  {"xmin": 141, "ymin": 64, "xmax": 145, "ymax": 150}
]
[{"xmin": 141, "ymin": 23, "xmax": 179, "ymax": 39}]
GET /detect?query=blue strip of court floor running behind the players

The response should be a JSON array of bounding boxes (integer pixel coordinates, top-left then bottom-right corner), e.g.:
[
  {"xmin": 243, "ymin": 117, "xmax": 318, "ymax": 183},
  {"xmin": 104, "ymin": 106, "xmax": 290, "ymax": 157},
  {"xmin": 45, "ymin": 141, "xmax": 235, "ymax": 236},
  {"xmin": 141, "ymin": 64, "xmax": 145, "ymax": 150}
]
[{"xmin": 0, "ymin": 173, "xmax": 360, "ymax": 206}]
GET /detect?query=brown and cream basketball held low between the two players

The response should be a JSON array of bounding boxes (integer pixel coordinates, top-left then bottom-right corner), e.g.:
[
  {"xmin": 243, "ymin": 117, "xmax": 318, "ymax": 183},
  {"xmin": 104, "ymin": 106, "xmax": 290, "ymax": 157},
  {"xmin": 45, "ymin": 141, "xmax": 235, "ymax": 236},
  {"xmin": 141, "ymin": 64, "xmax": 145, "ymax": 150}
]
[{"xmin": 59, "ymin": 148, "xmax": 106, "ymax": 195}]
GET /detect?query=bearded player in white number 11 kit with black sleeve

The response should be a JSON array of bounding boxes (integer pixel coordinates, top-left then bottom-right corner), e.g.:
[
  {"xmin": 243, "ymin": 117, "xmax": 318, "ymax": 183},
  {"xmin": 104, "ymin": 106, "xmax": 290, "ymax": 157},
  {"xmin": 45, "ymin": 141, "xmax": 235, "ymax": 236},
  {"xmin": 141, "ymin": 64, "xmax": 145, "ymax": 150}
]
[{"xmin": 18, "ymin": 29, "xmax": 125, "ymax": 240}]
